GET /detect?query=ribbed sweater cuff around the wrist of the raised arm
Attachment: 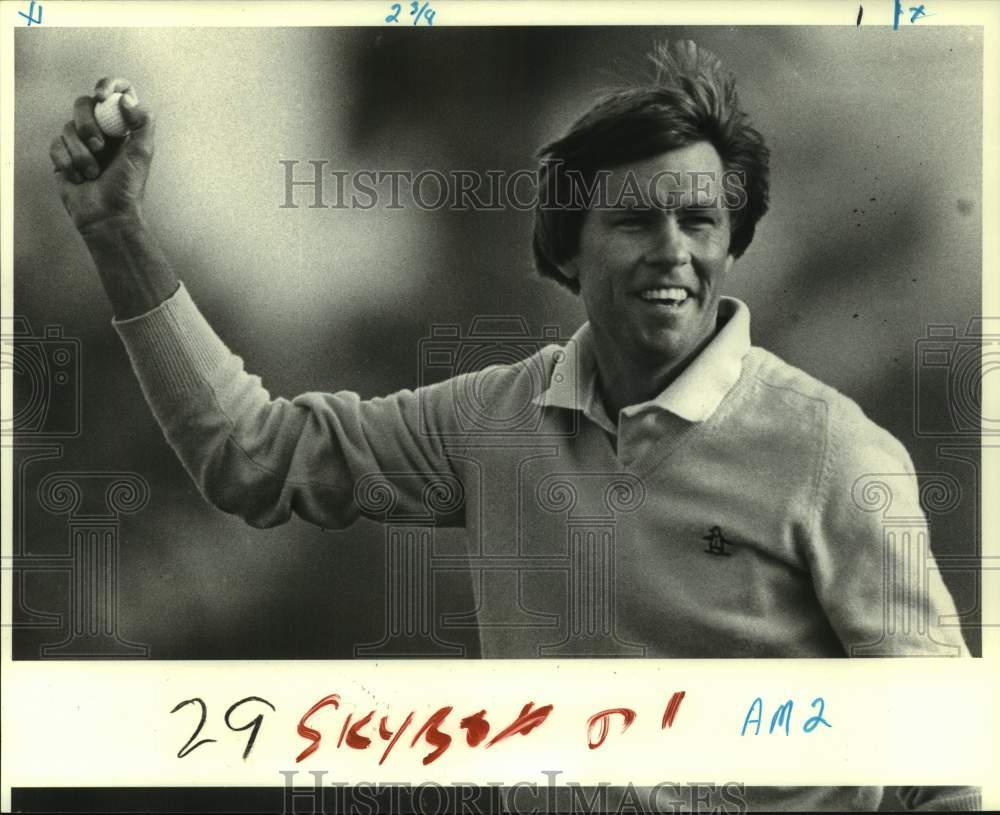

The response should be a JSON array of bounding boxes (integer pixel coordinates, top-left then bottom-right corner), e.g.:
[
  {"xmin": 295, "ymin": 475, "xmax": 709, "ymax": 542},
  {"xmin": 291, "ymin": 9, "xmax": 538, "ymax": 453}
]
[{"xmin": 111, "ymin": 283, "xmax": 231, "ymax": 399}]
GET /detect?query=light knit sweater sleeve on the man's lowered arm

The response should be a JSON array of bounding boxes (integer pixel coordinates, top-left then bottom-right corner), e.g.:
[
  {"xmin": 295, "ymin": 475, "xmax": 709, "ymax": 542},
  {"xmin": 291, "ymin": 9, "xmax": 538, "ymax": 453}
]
[{"xmin": 809, "ymin": 401, "xmax": 968, "ymax": 657}]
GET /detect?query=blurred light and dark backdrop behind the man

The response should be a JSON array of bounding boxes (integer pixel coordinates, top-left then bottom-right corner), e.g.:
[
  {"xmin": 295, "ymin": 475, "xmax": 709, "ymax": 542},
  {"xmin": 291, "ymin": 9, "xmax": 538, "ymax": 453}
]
[{"xmin": 14, "ymin": 26, "xmax": 982, "ymax": 659}]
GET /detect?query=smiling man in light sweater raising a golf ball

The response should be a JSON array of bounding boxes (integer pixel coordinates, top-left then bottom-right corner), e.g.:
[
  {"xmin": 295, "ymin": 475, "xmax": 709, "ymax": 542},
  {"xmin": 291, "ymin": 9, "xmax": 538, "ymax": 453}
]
[{"xmin": 51, "ymin": 38, "xmax": 978, "ymax": 810}]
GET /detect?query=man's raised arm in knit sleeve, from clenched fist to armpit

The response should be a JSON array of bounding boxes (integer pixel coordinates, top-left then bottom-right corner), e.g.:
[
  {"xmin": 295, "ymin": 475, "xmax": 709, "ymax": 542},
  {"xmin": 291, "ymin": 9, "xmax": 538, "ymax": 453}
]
[{"xmin": 50, "ymin": 79, "xmax": 460, "ymax": 528}]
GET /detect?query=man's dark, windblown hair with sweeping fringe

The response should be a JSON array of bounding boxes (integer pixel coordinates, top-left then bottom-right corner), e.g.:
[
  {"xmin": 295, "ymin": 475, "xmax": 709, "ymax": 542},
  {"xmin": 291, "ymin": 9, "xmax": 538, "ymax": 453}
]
[{"xmin": 533, "ymin": 41, "xmax": 769, "ymax": 292}]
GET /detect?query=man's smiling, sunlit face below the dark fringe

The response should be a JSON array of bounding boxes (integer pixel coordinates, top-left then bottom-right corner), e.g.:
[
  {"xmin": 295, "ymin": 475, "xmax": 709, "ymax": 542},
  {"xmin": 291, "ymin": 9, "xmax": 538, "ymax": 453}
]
[{"xmin": 561, "ymin": 142, "xmax": 733, "ymax": 373}]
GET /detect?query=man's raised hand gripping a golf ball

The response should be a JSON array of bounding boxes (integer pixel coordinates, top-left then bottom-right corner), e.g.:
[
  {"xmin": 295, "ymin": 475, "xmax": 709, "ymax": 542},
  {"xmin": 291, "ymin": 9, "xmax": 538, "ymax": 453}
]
[{"xmin": 49, "ymin": 78, "xmax": 154, "ymax": 233}]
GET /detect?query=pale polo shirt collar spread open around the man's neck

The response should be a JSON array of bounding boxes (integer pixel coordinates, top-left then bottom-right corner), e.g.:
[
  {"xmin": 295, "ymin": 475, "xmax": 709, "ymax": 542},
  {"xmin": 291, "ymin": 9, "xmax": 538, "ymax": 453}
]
[{"xmin": 534, "ymin": 297, "xmax": 750, "ymax": 433}]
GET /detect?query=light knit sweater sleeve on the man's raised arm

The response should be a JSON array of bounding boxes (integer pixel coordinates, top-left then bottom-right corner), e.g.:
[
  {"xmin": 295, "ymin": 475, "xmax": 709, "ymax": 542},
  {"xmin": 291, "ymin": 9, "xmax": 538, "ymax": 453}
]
[{"xmin": 114, "ymin": 284, "xmax": 461, "ymax": 528}]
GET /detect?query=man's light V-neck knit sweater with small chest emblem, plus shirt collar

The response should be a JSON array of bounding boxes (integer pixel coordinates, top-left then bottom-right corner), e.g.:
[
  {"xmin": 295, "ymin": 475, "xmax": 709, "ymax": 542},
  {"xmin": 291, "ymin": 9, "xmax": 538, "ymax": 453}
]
[{"xmin": 116, "ymin": 286, "xmax": 979, "ymax": 810}]
